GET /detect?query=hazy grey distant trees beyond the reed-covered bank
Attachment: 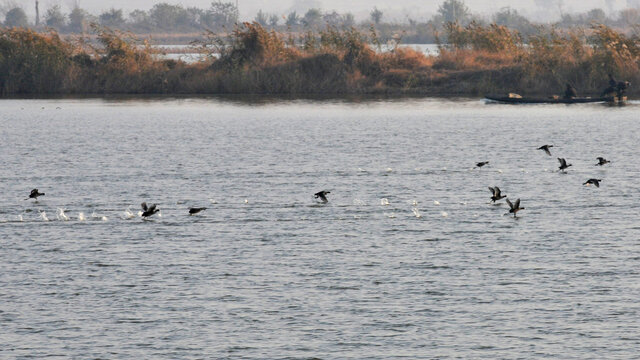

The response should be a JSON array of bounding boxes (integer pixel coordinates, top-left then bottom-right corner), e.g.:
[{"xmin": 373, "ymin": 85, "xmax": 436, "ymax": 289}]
[{"xmin": 0, "ymin": 0, "xmax": 640, "ymax": 43}]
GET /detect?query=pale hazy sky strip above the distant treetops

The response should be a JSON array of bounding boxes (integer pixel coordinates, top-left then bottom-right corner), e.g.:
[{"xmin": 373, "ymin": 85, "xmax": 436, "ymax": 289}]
[{"xmin": 15, "ymin": 0, "xmax": 640, "ymax": 20}]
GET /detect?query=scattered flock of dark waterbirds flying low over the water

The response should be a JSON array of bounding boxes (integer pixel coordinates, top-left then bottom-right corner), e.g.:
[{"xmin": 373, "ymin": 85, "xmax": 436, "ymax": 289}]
[{"xmin": 25, "ymin": 144, "xmax": 611, "ymax": 218}]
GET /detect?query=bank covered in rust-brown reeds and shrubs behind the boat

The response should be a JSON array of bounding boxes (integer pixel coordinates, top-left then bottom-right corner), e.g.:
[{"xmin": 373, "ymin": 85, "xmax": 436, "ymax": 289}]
[{"xmin": 0, "ymin": 23, "xmax": 640, "ymax": 98}]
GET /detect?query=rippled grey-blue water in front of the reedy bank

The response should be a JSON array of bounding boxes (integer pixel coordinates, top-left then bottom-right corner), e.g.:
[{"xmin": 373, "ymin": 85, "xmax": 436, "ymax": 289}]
[{"xmin": 0, "ymin": 99, "xmax": 640, "ymax": 359}]
